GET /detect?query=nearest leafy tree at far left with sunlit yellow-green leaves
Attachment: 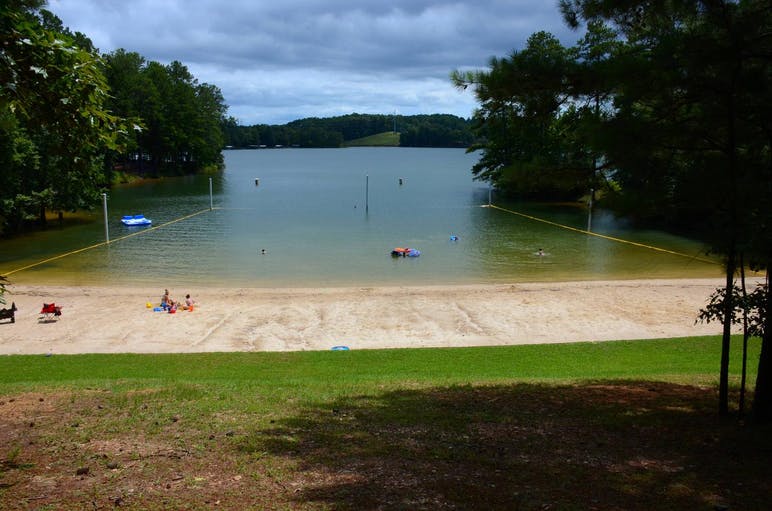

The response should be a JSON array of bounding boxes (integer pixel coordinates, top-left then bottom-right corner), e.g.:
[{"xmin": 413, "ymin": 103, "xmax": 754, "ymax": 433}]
[{"xmin": 0, "ymin": 1, "xmax": 130, "ymax": 231}]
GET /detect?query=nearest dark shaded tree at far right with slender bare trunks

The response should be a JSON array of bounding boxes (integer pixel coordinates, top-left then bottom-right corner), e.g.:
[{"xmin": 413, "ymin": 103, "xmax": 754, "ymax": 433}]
[{"xmin": 561, "ymin": 0, "xmax": 772, "ymax": 419}]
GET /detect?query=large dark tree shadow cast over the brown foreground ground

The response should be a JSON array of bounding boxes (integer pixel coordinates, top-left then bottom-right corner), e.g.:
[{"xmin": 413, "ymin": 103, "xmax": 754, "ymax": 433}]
[{"xmin": 244, "ymin": 381, "xmax": 772, "ymax": 510}]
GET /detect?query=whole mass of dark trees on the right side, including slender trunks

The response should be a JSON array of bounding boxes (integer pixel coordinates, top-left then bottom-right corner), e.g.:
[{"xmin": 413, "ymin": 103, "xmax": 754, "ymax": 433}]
[{"xmin": 453, "ymin": 0, "xmax": 772, "ymax": 421}]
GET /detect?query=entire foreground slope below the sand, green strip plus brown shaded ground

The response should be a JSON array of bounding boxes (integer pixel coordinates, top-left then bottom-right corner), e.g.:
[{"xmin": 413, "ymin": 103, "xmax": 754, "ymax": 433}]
[{"xmin": 0, "ymin": 337, "xmax": 772, "ymax": 510}]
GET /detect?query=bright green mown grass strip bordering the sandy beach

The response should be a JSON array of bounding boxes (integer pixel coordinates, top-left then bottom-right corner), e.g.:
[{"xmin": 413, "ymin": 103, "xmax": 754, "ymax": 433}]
[{"xmin": 0, "ymin": 337, "xmax": 759, "ymax": 390}]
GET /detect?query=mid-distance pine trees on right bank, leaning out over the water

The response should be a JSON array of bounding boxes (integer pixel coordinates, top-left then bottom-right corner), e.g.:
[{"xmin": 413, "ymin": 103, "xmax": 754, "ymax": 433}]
[{"xmin": 451, "ymin": 28, "xmax": 606, "ymax": 199}]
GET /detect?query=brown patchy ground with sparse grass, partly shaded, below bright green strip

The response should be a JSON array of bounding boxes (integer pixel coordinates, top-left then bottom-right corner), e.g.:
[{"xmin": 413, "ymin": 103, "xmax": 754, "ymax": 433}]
[{"xmin": 0, "ymin": 382, "xmax": 772, "ymax": 510}]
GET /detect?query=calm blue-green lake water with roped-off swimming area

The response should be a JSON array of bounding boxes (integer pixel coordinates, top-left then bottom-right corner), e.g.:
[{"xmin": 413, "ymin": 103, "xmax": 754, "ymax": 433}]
[{"xmin": 0, "ymin": 148, "xmax": 721, "ymax": 287}]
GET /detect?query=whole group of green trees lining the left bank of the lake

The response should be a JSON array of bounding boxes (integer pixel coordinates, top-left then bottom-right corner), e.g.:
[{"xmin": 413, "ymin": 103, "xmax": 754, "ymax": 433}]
[{"xmin": 0, "ymin": 0, "xmax": 226, "ymax": 235}]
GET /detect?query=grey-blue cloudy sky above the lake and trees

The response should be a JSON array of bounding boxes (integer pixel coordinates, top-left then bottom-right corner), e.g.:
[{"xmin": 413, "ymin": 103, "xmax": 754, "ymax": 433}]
[{"xmin": 47, "ymin": 0, "xmax": 579, "ymax": 125}]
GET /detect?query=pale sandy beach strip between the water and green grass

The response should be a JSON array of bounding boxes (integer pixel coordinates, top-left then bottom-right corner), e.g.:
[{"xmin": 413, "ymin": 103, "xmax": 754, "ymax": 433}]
[{"xmin": 0, "ymin": 279, "xmax": 744, "ymax": 354}]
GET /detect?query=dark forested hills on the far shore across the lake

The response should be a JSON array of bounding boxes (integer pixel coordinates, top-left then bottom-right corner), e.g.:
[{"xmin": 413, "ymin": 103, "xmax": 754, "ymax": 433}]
[{"xmin": 223, "ymin": 113, "xmax": 474, "ymax": 149}]
